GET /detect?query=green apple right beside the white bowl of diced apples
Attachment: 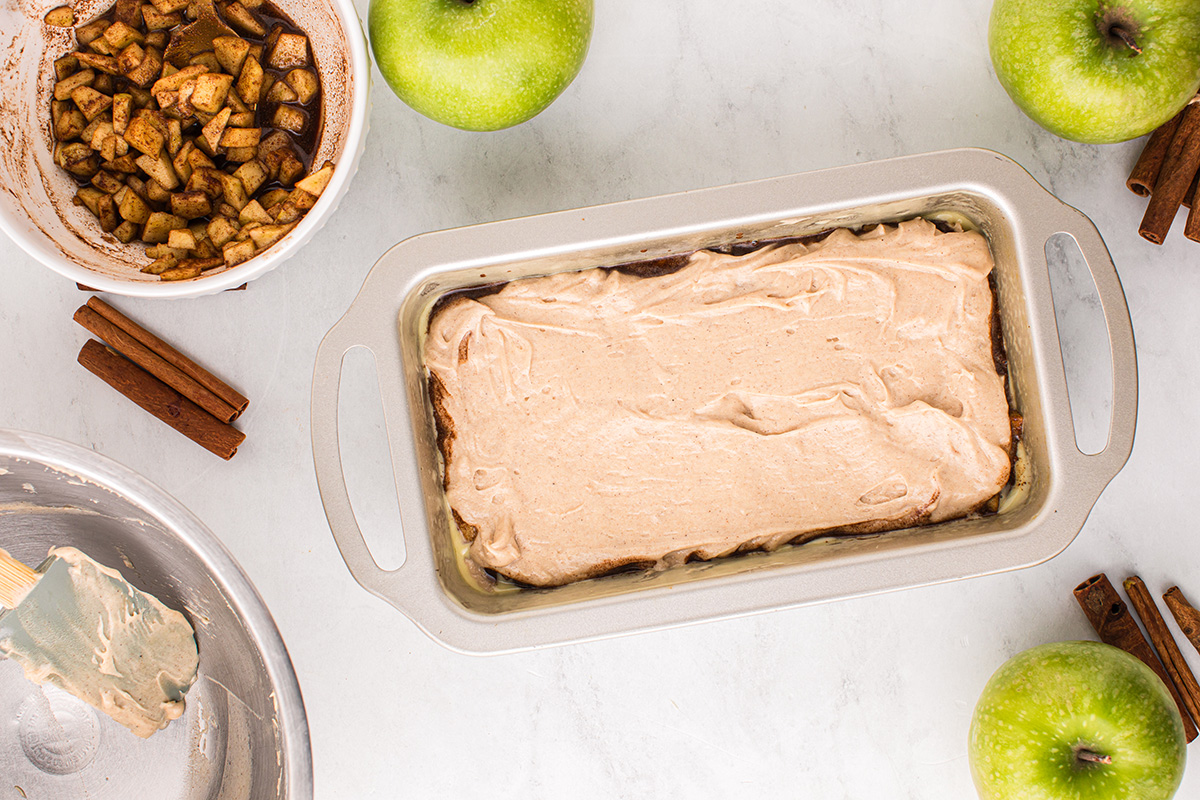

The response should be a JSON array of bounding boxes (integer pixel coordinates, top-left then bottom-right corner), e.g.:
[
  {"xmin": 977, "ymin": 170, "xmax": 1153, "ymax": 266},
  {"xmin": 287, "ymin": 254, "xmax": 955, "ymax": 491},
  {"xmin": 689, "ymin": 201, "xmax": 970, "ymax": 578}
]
[{"xmin": 367, "ymin": 0, "xmax": 593, "ymax": 131}]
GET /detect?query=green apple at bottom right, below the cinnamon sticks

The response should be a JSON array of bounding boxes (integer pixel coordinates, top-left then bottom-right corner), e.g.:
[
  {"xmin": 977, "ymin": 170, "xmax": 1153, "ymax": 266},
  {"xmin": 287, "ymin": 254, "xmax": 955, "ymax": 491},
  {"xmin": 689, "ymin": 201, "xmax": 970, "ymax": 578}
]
[{"xmin": 967, "ymin": 642, "xmax": 1187, "ymax": 800}]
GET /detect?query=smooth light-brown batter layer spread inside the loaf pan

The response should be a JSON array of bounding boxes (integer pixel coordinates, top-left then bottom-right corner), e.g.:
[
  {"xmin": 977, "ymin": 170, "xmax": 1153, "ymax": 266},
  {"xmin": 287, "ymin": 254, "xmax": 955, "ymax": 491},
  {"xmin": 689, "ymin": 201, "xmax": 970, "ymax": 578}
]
[{"xmin": 425, "ymin": 219, "xmax": 1010, "ymax": 587}]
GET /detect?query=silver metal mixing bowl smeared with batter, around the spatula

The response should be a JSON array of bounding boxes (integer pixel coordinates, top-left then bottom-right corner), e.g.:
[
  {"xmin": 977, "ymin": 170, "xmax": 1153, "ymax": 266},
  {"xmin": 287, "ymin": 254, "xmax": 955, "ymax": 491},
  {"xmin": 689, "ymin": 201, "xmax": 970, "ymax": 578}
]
[{"xmin": 0, "ymin": 429, "xmax": 312, "ymax": 800}]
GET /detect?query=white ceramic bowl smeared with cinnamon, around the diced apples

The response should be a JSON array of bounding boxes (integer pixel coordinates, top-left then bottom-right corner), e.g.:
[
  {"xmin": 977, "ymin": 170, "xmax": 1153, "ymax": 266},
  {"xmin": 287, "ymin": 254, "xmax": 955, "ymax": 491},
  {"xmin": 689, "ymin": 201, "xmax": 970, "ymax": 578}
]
[{"xmin": 0, "ymin": 0, "xmax": 371, "ymax": 297}]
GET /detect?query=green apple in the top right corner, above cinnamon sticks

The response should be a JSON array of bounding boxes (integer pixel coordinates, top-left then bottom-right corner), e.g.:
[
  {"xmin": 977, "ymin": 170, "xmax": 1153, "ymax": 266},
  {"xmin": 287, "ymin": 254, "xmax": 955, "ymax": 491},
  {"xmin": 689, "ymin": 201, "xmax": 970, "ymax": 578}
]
[{"xmin": 988, "ymin": 0, "xmax": 1200, "ymax": 144}]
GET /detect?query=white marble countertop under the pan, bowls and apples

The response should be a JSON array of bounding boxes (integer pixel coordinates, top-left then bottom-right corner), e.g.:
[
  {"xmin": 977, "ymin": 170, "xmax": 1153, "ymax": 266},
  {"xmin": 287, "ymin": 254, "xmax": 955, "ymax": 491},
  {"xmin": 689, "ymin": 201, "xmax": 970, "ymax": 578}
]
[{"xmin": 0, "ymin": 0, "xmax": 1200, "ymax": 800}]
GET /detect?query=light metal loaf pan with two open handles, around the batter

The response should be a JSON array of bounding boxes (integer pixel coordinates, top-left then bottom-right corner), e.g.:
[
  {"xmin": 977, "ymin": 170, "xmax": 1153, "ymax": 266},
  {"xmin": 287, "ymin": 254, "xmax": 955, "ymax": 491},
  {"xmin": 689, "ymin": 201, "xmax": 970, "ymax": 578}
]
[{"xmin": 312, "ymin": 149, "xmax": 1138, "ymax": 652}]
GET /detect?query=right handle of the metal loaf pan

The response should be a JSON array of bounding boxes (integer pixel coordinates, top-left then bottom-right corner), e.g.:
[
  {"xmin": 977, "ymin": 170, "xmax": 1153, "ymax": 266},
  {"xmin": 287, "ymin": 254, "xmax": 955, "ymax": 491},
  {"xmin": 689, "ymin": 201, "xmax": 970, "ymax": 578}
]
[{"xmin": 1037, "ymin": 201, "xmax": 1138, "ymax": 497}]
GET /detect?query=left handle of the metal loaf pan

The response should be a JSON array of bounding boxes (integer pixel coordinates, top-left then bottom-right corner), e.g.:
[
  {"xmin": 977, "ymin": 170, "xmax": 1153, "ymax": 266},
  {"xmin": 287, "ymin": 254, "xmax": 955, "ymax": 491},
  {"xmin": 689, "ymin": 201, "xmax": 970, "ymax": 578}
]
[{"xmin": 312, "ymin": 297, "xmax": 414, "ymax": 602}]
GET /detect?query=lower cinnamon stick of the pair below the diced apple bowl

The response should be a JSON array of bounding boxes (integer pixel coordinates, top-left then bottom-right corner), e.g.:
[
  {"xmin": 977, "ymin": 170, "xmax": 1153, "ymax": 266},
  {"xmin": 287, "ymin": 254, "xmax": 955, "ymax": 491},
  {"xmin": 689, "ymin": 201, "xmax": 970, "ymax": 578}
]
[{"xmin": 79, "ymin": 339, "xmax": 246, "ymax": 461}]
